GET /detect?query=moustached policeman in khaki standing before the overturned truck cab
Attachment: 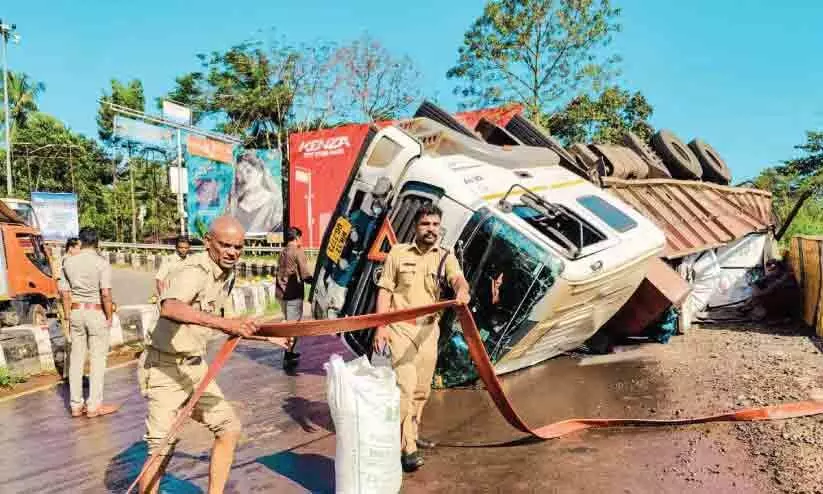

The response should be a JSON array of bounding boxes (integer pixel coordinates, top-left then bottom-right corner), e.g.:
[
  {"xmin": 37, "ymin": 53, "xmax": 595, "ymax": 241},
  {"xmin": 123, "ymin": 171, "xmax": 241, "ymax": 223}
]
[{"xmin": 373, "ymin": 205, "xmax": 469, "ymax": 472}]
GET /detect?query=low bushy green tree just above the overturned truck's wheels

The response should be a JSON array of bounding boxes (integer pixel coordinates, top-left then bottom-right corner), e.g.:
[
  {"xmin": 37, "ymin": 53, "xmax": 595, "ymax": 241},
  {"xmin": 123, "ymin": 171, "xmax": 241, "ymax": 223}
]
[{"xmin": 545, "ymin": 86, "xmax": 654, "ymax": 144}]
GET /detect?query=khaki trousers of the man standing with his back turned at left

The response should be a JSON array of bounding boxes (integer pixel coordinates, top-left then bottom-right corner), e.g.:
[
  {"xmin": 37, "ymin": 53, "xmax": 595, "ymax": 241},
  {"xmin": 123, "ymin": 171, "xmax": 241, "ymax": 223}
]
[{"xmin": 69, "ymin": 309, "xmax": 110, "ymax": 410}]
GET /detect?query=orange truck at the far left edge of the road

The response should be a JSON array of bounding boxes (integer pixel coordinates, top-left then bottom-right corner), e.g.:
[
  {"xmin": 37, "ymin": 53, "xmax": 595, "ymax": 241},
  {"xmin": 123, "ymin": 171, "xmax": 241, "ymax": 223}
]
[{"xmin": 0, "ymin": 201, "xmax": 58, "ymax": 326}]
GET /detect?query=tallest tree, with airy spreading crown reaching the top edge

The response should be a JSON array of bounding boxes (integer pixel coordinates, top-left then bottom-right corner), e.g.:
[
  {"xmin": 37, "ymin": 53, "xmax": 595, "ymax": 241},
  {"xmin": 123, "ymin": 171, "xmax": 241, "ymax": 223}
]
[{"xmin": 446, "ymin": 0, "xmax": 620, "ymax": 121}]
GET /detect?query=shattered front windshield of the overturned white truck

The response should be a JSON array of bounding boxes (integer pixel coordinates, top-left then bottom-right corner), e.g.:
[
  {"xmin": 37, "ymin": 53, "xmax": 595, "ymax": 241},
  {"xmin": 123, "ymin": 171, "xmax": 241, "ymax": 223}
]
[{"xmin": 438, "ymin": 209, "xmax": 562, "ymax": 386}]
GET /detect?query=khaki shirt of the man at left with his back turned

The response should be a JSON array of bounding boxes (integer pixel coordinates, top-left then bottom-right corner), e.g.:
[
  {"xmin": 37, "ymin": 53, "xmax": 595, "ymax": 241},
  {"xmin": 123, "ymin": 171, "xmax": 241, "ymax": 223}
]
[{"xmin": 58, "ymin": 249, "xmax": 111, "ymax": 304}]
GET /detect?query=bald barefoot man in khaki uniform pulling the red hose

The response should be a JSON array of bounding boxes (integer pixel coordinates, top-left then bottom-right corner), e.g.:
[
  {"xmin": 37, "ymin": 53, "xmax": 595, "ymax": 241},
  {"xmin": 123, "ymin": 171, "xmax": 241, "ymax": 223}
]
[{"xmin": 138, "ymin": 216, "xmax": 286, "ymax": 493}]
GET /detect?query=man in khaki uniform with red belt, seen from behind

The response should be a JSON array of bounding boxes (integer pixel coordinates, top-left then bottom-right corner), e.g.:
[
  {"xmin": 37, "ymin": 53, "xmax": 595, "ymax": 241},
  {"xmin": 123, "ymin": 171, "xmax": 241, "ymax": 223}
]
[{"xmin": 59, "ymin": 228, "xmax": 119, "ymax": 417}]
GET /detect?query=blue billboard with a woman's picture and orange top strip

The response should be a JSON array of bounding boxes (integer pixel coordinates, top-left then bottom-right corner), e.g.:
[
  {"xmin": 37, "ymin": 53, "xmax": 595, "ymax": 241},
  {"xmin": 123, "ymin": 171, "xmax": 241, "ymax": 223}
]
[{"xmin": 186, "ymin": 135, "xmax": 283, "ymax": 237}]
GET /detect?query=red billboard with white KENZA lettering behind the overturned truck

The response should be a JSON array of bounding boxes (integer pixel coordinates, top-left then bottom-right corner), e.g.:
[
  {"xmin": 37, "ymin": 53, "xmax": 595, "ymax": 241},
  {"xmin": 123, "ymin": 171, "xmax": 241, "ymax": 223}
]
[{"xmin": 289, "ymin": 124, "xmax": 369, "ymax": 249}]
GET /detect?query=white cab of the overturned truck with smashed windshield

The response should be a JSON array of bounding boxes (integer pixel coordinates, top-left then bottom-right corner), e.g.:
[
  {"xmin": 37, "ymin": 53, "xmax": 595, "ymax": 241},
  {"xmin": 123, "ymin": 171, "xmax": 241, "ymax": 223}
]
[{"xmin": 312, "ymin": 118, "xmax": 665, "ymax": 387}]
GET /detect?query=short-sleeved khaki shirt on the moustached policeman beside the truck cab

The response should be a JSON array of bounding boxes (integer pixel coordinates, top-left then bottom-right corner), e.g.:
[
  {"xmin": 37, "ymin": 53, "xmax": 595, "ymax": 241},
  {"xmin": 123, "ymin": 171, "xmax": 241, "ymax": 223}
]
[{"xmin": 377, "ymin": 243, "xmax": 463, "ymax": 331}]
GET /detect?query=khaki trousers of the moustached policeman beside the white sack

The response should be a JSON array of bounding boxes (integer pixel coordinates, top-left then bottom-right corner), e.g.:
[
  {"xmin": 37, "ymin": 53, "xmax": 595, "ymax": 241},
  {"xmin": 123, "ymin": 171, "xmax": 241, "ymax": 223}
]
[{"xmin": 389, "ymin": 323, "xmax": 440, "ymax": 453}]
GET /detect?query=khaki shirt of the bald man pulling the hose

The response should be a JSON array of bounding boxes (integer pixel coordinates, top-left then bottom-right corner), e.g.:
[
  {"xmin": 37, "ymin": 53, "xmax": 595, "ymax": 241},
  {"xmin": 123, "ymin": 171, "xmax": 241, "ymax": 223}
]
[{"xmin": 149, "ymin": 252, "xmax": 234, "ymax": 356}]
